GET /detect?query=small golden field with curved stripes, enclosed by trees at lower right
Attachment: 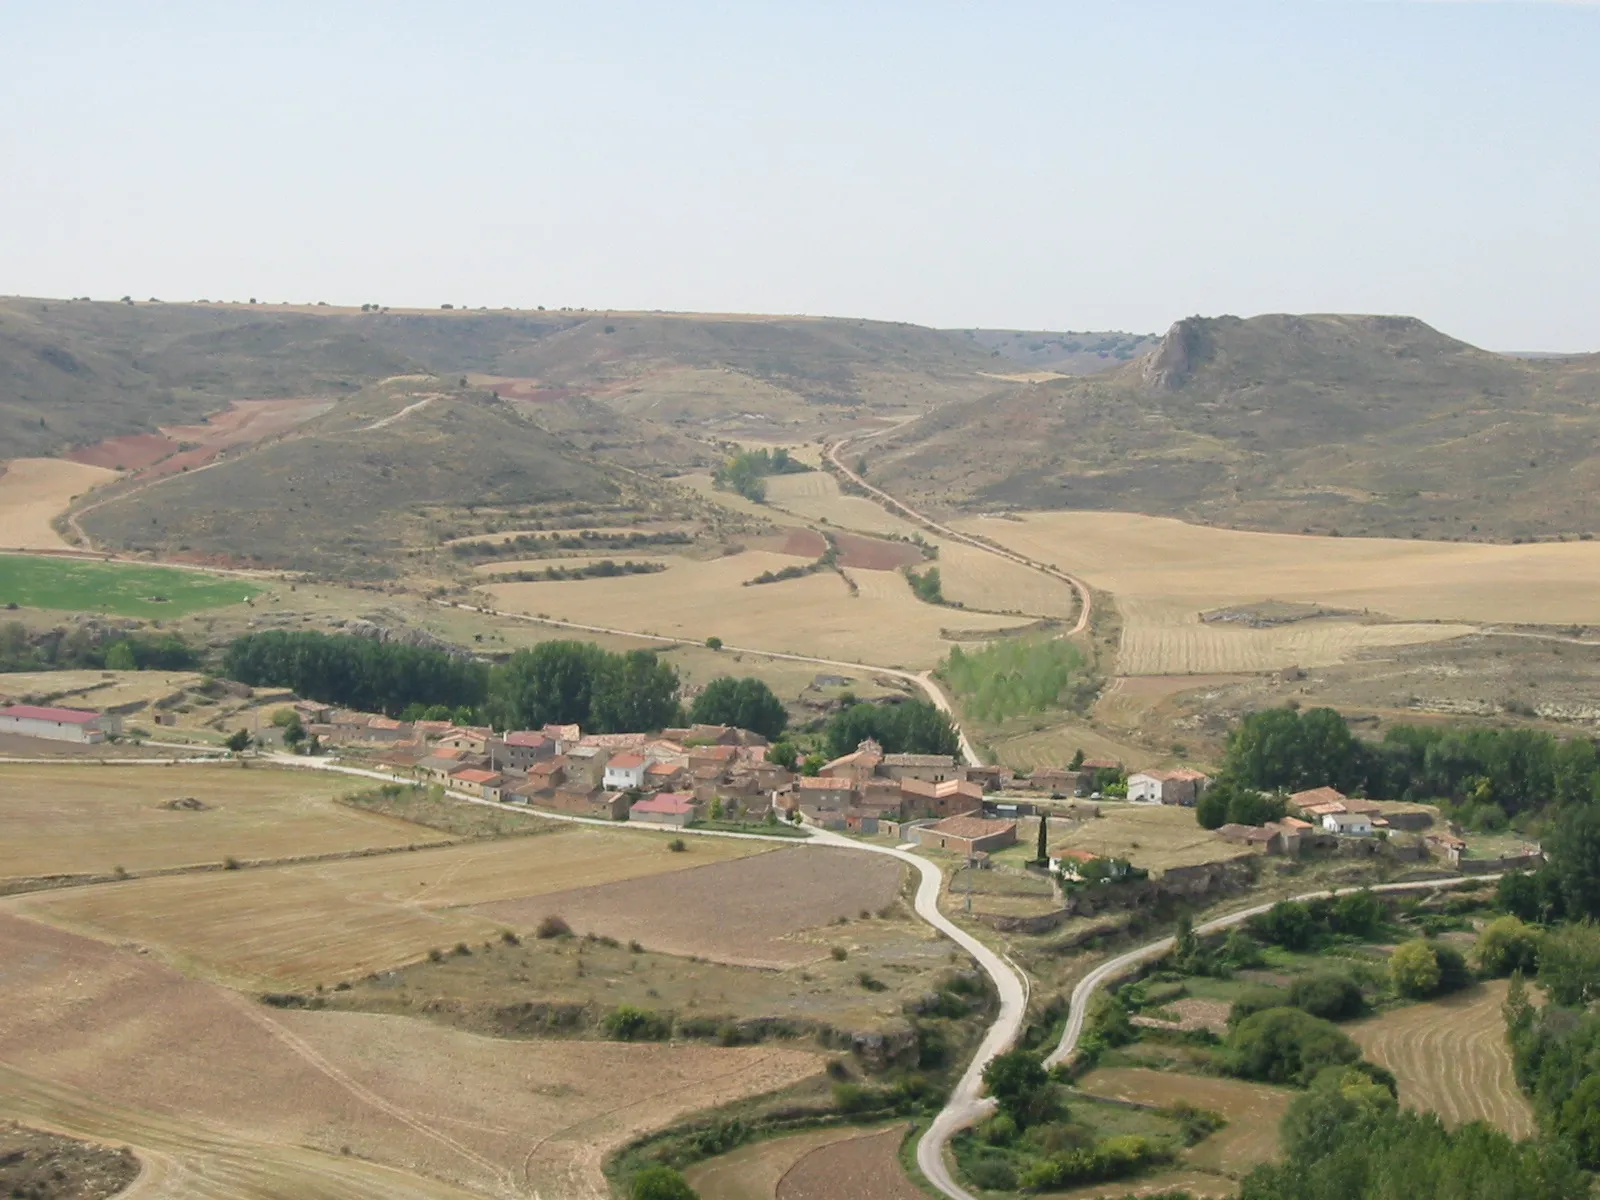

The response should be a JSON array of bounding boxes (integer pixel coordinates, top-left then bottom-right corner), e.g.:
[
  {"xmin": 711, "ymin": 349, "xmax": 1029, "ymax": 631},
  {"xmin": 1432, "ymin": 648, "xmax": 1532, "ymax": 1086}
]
[{"xmin": 1347, "ymin": 979, "xmax": 1536, "ymax": 1138}]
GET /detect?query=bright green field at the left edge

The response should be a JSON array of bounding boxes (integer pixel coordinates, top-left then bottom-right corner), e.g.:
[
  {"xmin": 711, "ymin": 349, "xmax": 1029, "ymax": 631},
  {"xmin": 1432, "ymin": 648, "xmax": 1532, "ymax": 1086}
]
[{"xmin": 0, "ymin": 554, "xmax": 261, "ymax": 618}]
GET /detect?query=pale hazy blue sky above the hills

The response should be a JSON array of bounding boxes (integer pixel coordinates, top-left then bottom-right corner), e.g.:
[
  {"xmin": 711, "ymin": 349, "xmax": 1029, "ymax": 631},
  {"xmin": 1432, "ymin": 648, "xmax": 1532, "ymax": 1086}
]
[{"xmin": 0, "ymin": 0, "xmax": 1600, "ymax": 350}]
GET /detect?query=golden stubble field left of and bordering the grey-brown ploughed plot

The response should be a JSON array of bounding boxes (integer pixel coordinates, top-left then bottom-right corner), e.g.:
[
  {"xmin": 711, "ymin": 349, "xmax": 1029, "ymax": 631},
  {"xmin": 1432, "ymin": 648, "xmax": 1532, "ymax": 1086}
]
[{"xmin": 8, "ymin": 813, "xmax": 766, "ymax": 989}]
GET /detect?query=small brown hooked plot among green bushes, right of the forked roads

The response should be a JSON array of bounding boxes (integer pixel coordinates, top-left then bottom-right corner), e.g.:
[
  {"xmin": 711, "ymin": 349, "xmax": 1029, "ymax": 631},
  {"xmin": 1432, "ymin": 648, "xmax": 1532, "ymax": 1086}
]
[{"xmin": 1077, "ymin": 1067, "xmax": 1294, "ymax": 1176}]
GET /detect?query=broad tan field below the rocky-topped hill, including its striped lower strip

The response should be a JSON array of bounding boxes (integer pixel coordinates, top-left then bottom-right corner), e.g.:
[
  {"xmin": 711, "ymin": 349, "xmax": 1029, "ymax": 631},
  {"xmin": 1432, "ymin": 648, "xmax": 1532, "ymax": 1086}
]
[{"xmin": 958, "ymin": 512, "xmax": 1600, "ymax": 675}]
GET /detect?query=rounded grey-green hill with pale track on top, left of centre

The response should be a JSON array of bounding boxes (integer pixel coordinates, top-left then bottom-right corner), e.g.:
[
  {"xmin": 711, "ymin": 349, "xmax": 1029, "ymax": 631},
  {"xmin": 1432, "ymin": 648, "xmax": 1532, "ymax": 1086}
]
[{"xmin": 78, "ymin": 376, "xmax": 688, "ymax": 578}]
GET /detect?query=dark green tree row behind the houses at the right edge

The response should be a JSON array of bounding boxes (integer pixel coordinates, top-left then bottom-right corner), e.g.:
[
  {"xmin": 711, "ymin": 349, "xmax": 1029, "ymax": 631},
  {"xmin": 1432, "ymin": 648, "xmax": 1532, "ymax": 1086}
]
[{"xmin": 1222, "ymin": 709, "xmax": 1600, "ymax": 824}]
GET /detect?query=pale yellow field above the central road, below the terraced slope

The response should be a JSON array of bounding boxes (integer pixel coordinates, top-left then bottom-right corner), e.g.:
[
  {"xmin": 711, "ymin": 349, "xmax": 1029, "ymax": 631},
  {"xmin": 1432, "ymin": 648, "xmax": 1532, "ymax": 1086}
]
[{"xmin": 483, "ymin": 550, "xmax": 1014, "ymax": 669}]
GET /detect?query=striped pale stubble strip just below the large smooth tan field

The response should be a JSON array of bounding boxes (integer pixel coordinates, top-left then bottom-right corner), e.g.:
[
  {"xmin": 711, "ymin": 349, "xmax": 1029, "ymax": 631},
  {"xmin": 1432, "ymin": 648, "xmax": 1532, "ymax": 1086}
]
[{"xmin": 1117, "ymin": 595, "xmax": 1477, "ymax": 675}]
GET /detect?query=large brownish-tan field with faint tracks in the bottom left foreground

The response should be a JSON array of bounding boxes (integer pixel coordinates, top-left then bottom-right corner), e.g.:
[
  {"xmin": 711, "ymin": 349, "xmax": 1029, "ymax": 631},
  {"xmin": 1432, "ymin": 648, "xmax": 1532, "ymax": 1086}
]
[{"xmin": 0, "ymin": 915, "xmax": 821, "ymax": 1200}]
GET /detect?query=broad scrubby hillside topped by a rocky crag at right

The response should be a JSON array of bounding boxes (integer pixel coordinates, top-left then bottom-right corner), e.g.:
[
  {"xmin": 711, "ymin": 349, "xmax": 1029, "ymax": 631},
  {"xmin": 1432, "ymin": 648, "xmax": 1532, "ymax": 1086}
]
[{"xmin": 862, "ymin": 315, "xmax": 1600, "ymax": 539}]
